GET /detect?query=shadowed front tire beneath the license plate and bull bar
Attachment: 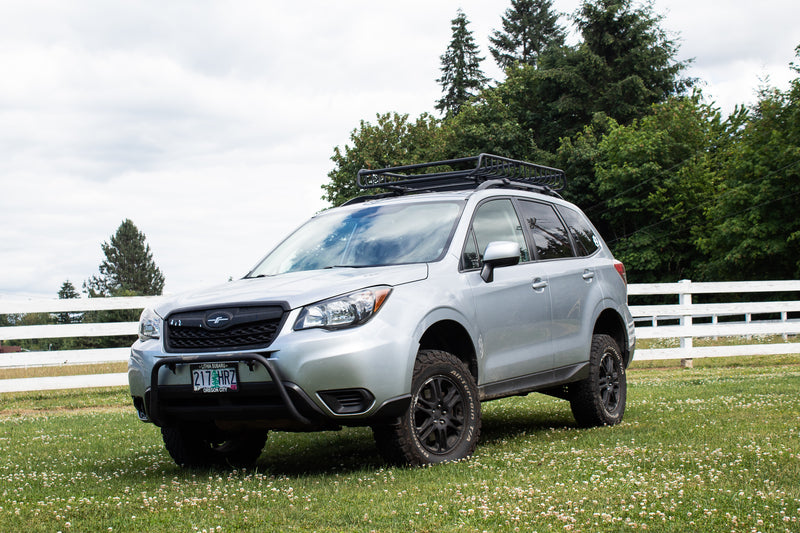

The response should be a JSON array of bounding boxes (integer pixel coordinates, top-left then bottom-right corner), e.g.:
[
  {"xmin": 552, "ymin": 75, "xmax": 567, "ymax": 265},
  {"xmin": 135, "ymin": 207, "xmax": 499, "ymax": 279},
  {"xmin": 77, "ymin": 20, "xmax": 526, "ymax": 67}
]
[{"xmin": 161, "ymin": 427, "xmax": 268, "ymax": 468}]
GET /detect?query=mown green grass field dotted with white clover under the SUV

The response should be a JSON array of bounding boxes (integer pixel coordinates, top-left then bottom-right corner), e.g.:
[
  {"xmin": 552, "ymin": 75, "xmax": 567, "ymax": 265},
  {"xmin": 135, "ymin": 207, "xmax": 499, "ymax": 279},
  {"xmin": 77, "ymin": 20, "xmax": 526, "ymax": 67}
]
[{"xmin": 0, "ymin": 356, "xmax": 800, "ymax": 533}]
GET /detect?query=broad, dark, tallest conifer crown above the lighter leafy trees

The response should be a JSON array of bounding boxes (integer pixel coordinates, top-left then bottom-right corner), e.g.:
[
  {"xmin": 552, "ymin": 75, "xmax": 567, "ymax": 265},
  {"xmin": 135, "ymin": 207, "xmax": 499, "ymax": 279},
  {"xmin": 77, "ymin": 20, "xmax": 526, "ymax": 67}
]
[{"xmin": 484, "ymin": 0, "xmax": 691, "ymax": 153}]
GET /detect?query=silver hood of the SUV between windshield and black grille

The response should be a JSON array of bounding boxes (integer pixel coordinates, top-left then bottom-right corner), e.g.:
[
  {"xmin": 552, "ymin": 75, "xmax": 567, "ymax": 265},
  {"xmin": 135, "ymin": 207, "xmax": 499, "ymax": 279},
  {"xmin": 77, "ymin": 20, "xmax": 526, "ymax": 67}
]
[{"xmin": 155, "ymin": 263, "xmax": 428, "ymax": 317}]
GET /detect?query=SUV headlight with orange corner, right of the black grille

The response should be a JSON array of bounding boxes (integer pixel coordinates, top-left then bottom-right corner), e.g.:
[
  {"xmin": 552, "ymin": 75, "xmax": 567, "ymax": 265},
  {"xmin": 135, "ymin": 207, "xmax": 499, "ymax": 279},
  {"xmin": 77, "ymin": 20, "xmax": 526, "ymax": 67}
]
[{"xmin": 294, "ymin": 286, "xmax": 392, "ymax": 330}]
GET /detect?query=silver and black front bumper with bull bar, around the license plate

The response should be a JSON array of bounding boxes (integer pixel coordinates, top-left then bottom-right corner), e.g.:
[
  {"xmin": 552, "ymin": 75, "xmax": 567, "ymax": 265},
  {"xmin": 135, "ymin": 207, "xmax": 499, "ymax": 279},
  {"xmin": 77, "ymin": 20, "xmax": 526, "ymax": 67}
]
[{"xmin": 128, "ymin": 304, "xmax": 416, "ymax": 431}]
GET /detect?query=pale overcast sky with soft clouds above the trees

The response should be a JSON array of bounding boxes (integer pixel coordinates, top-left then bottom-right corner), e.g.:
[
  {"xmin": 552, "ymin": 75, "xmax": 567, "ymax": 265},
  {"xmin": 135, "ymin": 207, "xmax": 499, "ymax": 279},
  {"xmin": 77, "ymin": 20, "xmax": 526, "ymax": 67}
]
[{"xmin": 0, "ymin": 0, "xmax": 800, "ymax": 298}]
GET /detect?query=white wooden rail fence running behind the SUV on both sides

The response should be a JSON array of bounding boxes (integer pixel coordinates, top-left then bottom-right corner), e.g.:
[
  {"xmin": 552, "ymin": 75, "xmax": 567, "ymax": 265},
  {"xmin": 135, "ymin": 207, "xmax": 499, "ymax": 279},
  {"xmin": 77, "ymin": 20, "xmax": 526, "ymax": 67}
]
[{"xmin": 0, "ymin": 280, "xmax": 800, "ymax": 393}]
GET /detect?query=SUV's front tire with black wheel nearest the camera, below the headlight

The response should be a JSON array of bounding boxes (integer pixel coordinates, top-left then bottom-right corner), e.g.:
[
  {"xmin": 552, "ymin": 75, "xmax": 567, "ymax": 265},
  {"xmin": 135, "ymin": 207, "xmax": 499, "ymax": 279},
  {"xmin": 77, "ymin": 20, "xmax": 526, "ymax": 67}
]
[{"xmin": 372, "ymin": 350, "xmax": 481, "ymax": 466}]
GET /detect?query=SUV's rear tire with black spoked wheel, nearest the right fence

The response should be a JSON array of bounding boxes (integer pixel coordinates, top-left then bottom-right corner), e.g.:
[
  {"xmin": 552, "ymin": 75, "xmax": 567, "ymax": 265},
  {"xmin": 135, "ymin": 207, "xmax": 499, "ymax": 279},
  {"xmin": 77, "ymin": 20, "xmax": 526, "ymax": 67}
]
[{"xmin": 569, "ymin": 335, "xmax": 627, "ymax": 427}]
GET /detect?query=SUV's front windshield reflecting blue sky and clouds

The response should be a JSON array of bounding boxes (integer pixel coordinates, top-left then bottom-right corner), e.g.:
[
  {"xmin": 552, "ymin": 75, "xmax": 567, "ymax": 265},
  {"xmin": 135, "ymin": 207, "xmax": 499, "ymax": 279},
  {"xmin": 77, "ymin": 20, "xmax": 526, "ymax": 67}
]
[{"xmin": 248, "ymin": 202, "xmax": 461, "ymax": 277}]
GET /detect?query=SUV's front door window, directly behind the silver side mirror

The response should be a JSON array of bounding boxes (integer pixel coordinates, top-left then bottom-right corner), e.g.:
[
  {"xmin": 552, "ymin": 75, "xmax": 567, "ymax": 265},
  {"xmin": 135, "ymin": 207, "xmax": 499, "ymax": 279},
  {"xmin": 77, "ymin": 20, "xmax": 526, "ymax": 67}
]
[{"xmin": 465, "ymin": 199, "xmax": 531, "ymax": 268}]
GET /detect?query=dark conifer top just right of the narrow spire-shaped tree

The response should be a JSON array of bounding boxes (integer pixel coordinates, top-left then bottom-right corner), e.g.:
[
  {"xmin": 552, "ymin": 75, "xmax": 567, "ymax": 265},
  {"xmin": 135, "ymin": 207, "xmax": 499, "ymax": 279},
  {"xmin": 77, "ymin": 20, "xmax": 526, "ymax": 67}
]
[{"xmin": 489, "ymin": 0, "xmax": 566, "ymax": 69}]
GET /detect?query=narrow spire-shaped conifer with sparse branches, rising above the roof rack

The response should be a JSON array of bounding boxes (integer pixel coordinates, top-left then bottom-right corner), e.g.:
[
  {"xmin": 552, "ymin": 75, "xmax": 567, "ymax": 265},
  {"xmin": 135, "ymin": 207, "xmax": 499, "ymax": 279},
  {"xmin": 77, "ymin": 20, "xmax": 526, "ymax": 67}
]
[{"xmin": 435, "ymin": 9, "xmax": 488, "ymax": 116}]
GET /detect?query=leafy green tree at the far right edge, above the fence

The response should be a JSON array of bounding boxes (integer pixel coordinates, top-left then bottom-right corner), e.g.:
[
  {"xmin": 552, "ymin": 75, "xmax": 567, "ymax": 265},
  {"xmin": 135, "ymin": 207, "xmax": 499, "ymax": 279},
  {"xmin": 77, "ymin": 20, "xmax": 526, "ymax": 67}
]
[{"xmin": 697, "ymin": 46, "xmax": 800, "ymax": 280}]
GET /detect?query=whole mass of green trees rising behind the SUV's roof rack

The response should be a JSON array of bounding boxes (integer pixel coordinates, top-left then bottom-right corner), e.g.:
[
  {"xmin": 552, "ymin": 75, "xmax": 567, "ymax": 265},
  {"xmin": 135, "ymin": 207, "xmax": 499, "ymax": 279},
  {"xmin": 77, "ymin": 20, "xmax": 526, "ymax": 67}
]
[{"xmin": 323, "ymin": 0, "xmax": 800, "ymax": 282}]
